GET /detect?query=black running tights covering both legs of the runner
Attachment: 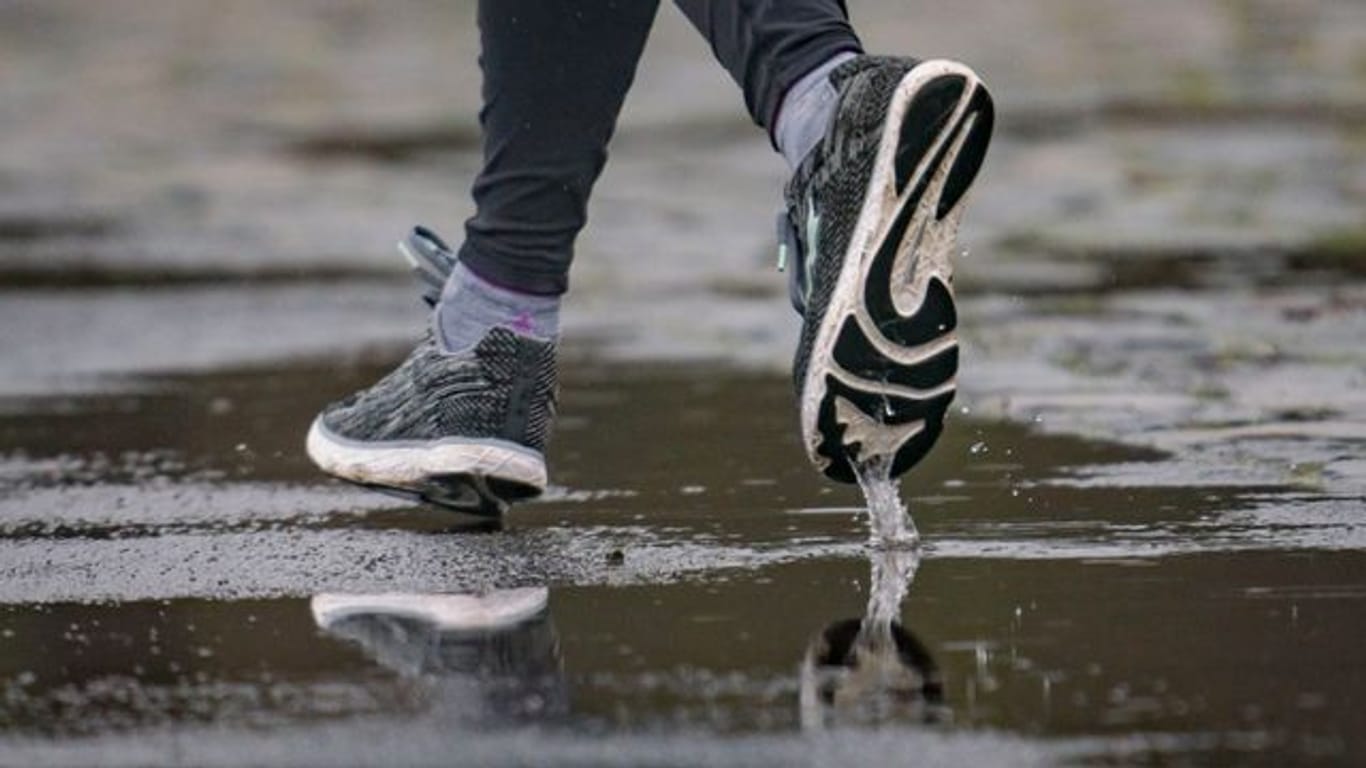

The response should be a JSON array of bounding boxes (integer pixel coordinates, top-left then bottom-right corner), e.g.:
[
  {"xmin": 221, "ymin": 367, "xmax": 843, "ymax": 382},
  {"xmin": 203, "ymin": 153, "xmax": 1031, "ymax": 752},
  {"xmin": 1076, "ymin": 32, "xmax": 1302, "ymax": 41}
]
[{"xmin": 460, "ymin": 0, "xmax": 861, "ymax": 295}]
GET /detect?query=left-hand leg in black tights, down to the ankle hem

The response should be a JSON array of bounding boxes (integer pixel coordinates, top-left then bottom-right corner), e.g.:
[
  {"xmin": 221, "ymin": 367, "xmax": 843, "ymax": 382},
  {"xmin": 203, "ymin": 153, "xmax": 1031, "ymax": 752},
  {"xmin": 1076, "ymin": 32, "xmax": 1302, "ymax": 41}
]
[{"xmin": 460, "ymin": 0, "xmax": 657, "ymax": 295}]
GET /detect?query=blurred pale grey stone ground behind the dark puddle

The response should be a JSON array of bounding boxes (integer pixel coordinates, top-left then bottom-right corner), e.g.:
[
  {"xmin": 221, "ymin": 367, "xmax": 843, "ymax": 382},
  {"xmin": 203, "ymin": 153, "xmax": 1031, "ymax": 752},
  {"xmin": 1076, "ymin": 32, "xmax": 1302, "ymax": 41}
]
[{"xmin": 0, "ymin": 0, "xmax": 1366, "ymax": 493}]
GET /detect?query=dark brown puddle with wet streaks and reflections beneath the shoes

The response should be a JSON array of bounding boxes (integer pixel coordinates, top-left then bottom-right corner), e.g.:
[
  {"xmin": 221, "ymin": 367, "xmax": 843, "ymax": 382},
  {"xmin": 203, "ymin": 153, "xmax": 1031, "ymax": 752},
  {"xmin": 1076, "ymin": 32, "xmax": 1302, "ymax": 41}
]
[{"xmin": 0, "ymin": 355, "xmax": 1366, "ymax": 765}]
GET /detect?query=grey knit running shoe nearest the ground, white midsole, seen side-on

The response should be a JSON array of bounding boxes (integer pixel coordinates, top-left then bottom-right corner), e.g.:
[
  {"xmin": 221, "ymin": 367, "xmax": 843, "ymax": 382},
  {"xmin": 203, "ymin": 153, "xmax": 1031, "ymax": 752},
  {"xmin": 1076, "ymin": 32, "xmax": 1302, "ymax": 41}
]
[{"xmin": 307, "ymin": 228, "xmax": 556, "ymax": 517}]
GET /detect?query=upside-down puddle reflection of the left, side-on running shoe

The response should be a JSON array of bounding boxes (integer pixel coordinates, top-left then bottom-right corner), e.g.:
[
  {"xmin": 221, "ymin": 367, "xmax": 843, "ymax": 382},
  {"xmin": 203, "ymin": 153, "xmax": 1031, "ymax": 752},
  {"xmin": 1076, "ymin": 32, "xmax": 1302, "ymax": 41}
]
[{"xmin": 310, "ymin": 588, "xmax": 568, "ymax": 724}]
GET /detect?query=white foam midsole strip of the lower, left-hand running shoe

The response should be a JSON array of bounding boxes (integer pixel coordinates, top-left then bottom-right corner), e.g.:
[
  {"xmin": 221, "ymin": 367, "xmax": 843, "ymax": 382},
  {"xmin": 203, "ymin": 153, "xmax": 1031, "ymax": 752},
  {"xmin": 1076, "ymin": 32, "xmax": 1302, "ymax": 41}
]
[{"xmin": 307, "ymin": 417, "xmax": 546, "ymax": 491}]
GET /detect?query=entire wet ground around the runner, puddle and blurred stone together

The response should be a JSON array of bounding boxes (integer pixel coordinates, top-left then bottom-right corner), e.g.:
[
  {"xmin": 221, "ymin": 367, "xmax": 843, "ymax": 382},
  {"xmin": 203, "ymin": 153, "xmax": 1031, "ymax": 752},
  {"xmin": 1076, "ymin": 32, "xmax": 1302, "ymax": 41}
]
[{"xmin": 0, "ymin": 0, "xmax": 1366, "ymax": 765}]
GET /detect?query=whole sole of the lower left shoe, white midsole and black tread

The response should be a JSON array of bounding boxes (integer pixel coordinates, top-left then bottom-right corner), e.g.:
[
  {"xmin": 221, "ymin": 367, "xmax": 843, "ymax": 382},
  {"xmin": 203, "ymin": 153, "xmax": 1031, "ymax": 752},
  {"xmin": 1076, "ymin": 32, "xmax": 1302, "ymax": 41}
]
[{"xmin": 307, "ymin": 417, "xmax": 546, "ymax": 517}]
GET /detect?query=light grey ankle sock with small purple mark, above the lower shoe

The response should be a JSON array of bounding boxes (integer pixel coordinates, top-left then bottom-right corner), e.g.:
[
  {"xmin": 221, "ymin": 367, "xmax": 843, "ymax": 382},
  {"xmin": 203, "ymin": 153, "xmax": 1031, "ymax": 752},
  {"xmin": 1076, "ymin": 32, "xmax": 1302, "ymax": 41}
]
[{"xmin": 436, "ymin": 262, "xmax": 560, "ymax": 353}]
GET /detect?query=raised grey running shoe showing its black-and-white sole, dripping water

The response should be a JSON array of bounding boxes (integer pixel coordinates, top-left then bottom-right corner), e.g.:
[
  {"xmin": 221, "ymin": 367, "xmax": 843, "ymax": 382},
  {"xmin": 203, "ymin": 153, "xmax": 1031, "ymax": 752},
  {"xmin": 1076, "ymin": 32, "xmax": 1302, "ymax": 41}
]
[{"xmin": 779, "ymin": 56, "xmax": 993, "ymax": 482}]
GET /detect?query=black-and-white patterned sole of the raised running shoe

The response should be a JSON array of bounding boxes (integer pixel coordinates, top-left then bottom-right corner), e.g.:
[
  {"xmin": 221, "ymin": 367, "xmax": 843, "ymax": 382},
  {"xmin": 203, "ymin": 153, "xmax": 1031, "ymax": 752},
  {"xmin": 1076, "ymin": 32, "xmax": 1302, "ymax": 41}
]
[{"xmin": 802, "ymin": 60, "xmax": 994, "ymax": 482}]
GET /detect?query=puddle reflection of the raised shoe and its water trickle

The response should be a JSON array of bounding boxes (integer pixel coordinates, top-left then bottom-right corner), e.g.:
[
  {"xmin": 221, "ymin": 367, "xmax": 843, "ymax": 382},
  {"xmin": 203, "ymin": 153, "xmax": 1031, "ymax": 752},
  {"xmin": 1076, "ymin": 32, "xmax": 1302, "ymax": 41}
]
[{"xmin": 799, "ymin": 549, "xmax": 948, "ymax": 730}]
